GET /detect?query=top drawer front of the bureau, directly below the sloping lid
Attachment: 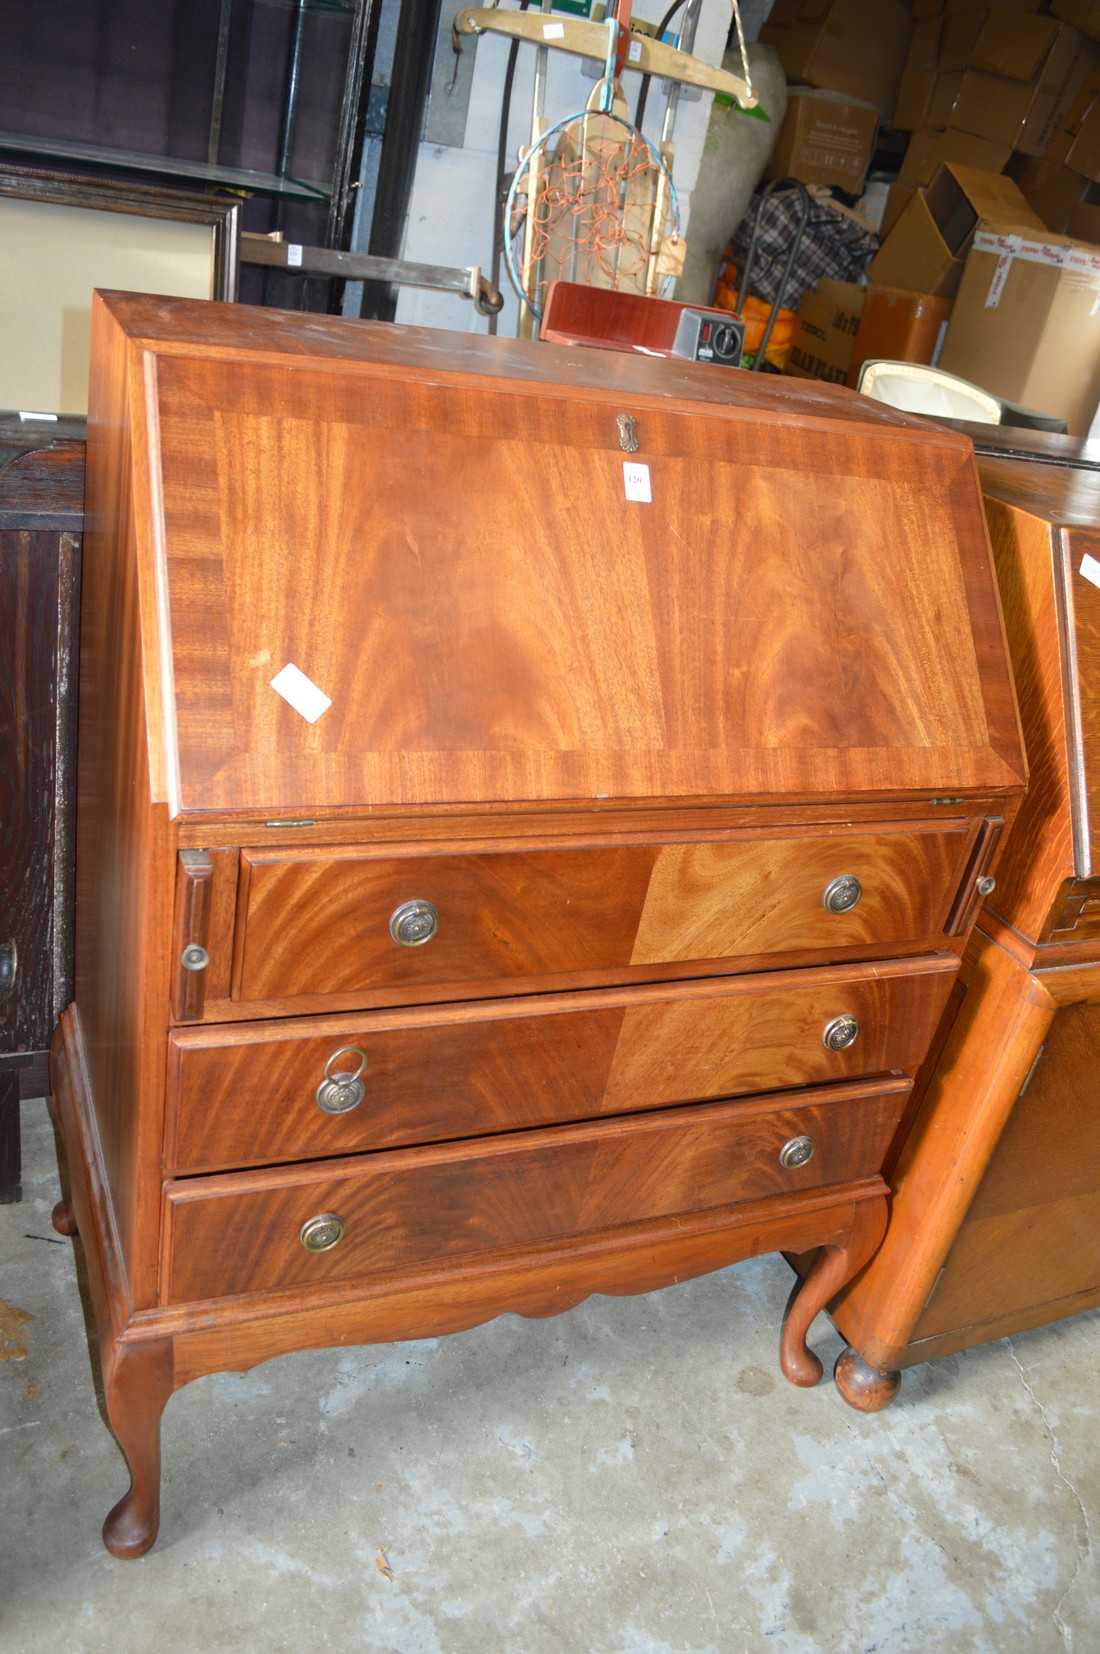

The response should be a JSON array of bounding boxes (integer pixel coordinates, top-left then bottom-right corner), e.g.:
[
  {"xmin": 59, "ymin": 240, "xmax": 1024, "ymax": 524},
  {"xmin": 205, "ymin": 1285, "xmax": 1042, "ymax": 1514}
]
[{"xmin": 235, "ymin": 820, "xmax": 973, "ymax": 999}]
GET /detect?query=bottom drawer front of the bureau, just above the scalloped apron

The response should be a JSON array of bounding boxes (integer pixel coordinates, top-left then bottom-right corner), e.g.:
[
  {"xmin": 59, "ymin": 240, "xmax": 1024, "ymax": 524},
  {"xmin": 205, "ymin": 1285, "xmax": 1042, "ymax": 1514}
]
[{"xmin": 165, "ymin": 1080, "xmax": 910, "ymax": 1303}]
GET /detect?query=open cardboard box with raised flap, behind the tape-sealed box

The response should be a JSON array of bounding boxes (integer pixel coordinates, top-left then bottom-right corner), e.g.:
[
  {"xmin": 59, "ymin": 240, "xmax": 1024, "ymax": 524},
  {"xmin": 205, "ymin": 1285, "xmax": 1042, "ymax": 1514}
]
[{"xmin": 868, "ymin": 164, "xmax": 1045, "ymax": 298}]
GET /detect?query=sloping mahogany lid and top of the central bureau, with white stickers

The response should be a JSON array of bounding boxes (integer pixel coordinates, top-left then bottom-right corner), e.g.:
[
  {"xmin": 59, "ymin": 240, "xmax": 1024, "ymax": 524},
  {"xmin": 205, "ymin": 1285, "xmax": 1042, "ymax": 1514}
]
[{"xmin": 89, "ymin": 296, "xmax": 1022, "ymax": 812}]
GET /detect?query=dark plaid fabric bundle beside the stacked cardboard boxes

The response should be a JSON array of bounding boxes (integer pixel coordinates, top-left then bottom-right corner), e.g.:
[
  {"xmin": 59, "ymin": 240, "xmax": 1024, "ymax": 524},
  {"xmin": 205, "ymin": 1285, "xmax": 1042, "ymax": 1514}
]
[{"xmin": 728, "ymin": 184, "xmax": 878, "ymax": 309}]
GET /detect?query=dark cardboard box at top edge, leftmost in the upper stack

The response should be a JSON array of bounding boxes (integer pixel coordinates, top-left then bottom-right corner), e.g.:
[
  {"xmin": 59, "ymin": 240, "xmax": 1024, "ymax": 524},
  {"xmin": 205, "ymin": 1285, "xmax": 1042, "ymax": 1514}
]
[{"xmin": 759, "ymin": 0, "xmax": 911, "ymax": 119}]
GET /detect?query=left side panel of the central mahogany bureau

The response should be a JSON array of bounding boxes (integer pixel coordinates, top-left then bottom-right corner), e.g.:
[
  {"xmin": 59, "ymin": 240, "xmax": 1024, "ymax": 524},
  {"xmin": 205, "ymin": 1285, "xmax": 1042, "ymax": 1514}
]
[{"xmin": 76, "ymin": 294, "xmax": 174, "ymax": 1308}]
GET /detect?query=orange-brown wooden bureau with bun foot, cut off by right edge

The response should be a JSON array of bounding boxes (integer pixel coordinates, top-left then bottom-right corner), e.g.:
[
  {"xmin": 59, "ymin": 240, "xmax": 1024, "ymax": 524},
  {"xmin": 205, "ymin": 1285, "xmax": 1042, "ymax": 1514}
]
[{"xmin": 823, "ymin": 457, "xmax": 1100, "ymax": 1409}]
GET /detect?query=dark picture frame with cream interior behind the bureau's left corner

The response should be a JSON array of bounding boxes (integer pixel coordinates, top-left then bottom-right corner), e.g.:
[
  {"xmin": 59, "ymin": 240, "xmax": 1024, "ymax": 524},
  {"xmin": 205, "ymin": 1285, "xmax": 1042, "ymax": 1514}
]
[{"xmin": 0, "ymin": 165, "xmax": 240, "ymax": 415}]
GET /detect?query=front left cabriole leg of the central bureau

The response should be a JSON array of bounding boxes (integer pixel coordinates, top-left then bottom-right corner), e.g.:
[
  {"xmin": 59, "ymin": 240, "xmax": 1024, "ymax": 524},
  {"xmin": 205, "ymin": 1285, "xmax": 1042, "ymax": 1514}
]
[{"xmin": 103, "ymin": 1338, "xmax": 172, "ymax": 1560}]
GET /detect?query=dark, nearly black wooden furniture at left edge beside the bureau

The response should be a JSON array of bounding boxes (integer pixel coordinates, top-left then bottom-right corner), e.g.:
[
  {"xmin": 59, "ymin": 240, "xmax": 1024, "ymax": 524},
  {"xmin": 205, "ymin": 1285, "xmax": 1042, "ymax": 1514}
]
[{"xmin": 0, "ymin": 414, "xmax": 84, "ymax": 1202}]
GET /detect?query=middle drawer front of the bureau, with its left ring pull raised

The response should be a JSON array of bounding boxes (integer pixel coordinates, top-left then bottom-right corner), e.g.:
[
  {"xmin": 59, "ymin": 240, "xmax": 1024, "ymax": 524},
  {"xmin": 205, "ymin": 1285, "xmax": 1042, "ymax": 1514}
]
[{"xmin": 167, "ymin": 954, "xmax": 958, "ymax": 1173}]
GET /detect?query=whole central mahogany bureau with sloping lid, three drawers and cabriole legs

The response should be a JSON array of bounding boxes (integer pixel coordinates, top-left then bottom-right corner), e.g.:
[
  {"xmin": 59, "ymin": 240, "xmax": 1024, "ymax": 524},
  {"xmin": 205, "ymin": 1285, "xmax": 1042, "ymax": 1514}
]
[{"xmin": 53, "ymin": 294, "xmax": 1024, "ymax": 1556}]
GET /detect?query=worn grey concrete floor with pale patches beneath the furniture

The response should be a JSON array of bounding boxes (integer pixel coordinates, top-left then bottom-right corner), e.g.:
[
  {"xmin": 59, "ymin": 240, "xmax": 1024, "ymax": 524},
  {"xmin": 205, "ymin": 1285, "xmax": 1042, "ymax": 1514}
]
[{"xmin": 0, "ymin": 1103, "xmax": 1100, "ymax": 1654}]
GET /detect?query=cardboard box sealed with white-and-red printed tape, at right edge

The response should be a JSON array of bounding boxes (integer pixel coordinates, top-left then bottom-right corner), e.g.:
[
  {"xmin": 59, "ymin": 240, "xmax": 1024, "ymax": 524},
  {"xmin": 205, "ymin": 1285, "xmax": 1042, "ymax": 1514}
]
[{"xmin": 940, "ymin": 223, "xmax": 1100, "ymax": 437}]
